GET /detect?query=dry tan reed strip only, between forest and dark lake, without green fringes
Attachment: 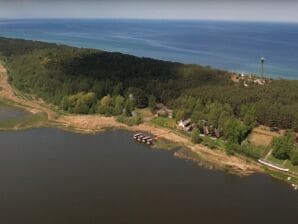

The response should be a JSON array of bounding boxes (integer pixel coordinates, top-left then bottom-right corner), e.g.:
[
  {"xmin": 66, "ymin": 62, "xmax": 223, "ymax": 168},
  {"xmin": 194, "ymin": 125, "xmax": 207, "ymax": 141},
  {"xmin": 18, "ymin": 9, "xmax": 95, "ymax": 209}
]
[{"xmin": 0, "ymin": 64, "xmax": 261, "ymax": 174}]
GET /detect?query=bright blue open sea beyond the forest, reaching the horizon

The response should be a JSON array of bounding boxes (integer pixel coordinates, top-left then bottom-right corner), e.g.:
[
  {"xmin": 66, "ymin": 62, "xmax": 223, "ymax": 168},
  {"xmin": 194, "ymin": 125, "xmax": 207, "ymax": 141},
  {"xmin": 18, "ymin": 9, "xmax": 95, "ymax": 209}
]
[{"xmin": 0, "ymin": 19, "xmax": 298, "ymax": 79}]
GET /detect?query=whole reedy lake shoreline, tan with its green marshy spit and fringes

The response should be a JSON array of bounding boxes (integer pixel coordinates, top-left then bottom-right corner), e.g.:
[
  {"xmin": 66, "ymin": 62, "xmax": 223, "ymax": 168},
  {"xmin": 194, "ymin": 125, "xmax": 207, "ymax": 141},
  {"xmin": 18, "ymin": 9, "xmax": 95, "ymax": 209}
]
[{"xmin": 0, "ymin": 63, "xmax": 298, "ymax": 186}]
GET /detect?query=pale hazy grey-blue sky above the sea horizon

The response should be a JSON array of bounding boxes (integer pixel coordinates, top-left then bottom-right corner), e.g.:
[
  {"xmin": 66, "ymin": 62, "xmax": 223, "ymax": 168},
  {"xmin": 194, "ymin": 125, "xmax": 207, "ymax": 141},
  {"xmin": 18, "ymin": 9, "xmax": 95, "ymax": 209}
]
[{"xmin": 0, "ymin": 0, "xmax": 298, "ymax": 22}]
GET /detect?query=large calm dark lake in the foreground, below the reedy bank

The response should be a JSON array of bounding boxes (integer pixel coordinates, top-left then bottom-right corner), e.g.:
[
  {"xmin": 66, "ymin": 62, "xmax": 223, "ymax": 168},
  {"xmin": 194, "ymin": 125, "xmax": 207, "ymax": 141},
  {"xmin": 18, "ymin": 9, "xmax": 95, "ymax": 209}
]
[{"xmin": 0, "ymin": 128, "xmax": 298, "ymax": 224}]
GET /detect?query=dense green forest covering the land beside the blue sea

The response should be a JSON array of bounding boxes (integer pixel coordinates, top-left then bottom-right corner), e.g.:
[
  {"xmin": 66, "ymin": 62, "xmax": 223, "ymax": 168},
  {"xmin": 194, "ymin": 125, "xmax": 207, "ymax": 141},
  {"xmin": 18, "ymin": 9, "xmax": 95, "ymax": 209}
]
[{"xmin": 0, "ymin": 38, "xmax": 298, "ymax": 133}]
